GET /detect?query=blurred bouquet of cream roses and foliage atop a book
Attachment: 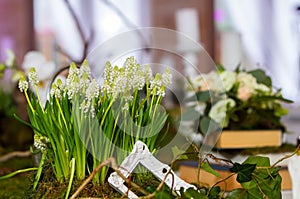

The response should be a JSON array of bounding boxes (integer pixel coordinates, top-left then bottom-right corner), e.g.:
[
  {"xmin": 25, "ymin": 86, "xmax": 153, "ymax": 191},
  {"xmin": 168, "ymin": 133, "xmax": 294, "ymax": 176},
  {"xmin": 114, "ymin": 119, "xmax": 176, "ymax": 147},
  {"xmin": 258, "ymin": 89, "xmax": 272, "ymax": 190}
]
[{"xmin": 186, "ymin": 65, "xmax": 291, "ymax": 134}]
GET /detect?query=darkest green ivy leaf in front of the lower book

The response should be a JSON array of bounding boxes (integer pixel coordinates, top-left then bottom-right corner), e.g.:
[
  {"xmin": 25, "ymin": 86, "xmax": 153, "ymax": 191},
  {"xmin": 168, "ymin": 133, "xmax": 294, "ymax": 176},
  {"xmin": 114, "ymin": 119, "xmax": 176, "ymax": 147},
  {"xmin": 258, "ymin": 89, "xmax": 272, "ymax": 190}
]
[{"xmin": 229, "ymin": 163, "xmax": 256, "ymax": 183}]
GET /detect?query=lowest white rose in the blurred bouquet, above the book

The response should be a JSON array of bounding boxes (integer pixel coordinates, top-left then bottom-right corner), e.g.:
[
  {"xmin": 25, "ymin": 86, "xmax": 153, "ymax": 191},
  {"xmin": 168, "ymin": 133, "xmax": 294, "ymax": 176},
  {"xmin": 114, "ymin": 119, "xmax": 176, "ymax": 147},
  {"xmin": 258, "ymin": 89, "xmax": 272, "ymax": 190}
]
[{"xmin": 209, "ymin": 98, "xmax": 235, "ymax": 127}]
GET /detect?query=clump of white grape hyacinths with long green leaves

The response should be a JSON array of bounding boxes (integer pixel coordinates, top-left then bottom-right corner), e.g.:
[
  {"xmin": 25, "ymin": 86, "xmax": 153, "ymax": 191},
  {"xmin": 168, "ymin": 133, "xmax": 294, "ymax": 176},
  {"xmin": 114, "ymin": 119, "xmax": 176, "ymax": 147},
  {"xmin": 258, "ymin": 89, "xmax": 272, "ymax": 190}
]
[{"xmin": 19, "ymin": 57, "xmax": 171, "ymax": 196}]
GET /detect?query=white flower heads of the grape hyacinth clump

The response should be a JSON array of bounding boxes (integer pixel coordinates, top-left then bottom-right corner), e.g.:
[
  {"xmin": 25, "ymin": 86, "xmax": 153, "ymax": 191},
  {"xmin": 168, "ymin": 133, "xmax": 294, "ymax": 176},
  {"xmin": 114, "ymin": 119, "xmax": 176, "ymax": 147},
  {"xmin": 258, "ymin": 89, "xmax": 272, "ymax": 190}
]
[{"xmin": 19, "ymin": 57, "xmax": 172, "ymax": 116}]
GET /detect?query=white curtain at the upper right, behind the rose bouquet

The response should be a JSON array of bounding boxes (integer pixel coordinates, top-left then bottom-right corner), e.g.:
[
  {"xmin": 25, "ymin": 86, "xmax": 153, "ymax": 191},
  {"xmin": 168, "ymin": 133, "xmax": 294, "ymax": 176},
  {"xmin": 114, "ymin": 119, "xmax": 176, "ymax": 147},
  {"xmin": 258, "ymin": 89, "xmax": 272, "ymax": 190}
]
[{"xmin": 225, "ymin": 0, "xmax": 300, "ymax": 102}]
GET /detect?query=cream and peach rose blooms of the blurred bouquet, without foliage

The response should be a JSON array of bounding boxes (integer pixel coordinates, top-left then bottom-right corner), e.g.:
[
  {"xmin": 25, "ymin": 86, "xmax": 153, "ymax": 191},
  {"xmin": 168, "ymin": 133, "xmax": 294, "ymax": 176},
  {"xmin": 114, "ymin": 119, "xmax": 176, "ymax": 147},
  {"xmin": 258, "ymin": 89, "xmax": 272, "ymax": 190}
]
[{"xmin": 191, "ymin": 67, "xmax": 274, "ymax": 127}]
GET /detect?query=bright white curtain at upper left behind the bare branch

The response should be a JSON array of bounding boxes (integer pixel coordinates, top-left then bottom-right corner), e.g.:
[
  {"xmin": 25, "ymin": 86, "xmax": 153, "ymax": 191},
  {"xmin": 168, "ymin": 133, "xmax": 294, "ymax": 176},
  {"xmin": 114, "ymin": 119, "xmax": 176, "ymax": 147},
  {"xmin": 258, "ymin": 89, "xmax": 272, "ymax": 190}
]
[{"xmin": 34, "ymin": 0, "xmax": 141, "ymax": 69}]
